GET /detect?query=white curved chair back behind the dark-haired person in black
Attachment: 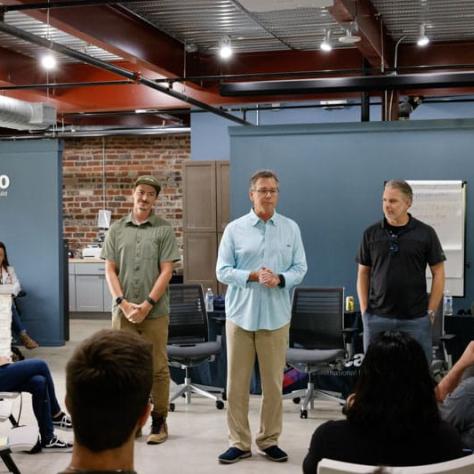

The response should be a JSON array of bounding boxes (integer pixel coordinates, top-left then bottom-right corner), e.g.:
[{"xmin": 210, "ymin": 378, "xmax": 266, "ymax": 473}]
[{"xmin": 318, "ymin": 454, "xmax": 474, "ymax": 474}]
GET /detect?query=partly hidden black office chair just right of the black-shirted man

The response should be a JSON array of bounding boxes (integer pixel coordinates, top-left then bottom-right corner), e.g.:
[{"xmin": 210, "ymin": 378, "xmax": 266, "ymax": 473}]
[{"xmin": 431, "ymin": 301, "xmax": 456, "ymax": 381}]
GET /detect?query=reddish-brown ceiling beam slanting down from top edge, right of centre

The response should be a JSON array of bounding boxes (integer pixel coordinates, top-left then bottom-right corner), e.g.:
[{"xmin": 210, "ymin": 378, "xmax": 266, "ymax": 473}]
[{"xmin": 330, "ymin": 0, "xmax": 394, "ymax": 69}]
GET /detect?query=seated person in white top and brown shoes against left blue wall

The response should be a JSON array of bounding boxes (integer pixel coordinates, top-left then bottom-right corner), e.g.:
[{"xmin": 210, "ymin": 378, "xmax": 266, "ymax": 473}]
[{"xmin": 0, "ymin": 242, "xmax": 38, "ymax": 349}]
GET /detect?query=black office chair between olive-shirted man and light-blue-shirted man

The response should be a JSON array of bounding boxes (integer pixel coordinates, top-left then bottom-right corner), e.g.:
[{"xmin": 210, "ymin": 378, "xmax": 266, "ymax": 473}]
[{"xmin": 167, "ymin": 284, "xmax": 224, "ymax": 411}]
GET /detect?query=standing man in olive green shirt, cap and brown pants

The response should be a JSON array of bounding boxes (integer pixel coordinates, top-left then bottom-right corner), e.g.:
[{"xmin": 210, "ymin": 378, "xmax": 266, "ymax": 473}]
[{"xmin": 101, "ymin": 175, "xmax": 180, "ymax": 444}]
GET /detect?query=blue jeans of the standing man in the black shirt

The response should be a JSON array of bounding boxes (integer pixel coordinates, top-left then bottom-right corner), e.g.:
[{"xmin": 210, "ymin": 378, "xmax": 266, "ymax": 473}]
[{"xmin": 362, "ymin": 311, "xmax": 433, "ymax": 364}]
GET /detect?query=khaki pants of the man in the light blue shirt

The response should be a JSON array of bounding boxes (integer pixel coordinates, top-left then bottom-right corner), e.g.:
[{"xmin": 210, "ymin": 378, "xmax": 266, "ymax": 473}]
[{"xmin": 226, "ymin": 320, "xmax": 290, "ymax": 451}]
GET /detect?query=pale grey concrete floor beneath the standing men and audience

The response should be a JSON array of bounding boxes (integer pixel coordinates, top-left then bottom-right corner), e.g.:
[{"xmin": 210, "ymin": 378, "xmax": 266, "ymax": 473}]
[{"xmin": 0, "ymin": 319, "xmax": 341, "ymax": 474}]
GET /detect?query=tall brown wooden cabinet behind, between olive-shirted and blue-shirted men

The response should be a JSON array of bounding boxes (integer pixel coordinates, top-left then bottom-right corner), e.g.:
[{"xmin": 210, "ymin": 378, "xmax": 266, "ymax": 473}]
[{"xmin": 183, "ymin": 161, "xmax": 230, "ymax": 294}]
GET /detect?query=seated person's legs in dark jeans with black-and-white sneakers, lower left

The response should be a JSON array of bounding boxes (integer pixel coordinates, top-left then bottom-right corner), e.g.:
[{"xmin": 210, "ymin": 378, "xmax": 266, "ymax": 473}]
[{"xmin": 0, "ymin": 356, "xmax": 72, "ymax": 453}]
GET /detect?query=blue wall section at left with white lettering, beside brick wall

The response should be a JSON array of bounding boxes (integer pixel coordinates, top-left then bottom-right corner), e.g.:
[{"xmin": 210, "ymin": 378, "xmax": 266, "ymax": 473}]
[{"xmin": 0, "ymin": 140, "xmax": 64, "ymax": 346}]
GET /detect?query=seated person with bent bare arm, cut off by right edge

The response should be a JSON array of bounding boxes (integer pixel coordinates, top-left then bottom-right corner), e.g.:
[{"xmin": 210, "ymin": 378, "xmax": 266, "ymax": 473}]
[{"xmin": 436, "ymin": 341, "xmax": 474, "ymax": 450}]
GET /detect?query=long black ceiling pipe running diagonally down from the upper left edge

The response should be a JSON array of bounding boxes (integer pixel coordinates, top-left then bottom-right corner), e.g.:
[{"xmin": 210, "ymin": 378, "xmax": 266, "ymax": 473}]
[{"xmin": 0, "ymin": 21, "xmax": 252, "ymax": 125}]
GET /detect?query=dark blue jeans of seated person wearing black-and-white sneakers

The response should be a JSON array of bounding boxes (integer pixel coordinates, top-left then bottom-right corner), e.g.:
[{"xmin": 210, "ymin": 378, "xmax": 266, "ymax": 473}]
[{"xmin": 0, "ymin": 359, "xmax": 61, "ymax": 445}]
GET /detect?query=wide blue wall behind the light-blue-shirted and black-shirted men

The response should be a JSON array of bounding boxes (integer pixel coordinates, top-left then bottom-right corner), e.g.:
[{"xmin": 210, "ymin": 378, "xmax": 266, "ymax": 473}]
[{"xmin": 230, "ymin": 120, "xmax": 474, "ymax": 308}]
